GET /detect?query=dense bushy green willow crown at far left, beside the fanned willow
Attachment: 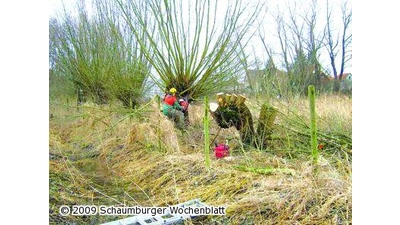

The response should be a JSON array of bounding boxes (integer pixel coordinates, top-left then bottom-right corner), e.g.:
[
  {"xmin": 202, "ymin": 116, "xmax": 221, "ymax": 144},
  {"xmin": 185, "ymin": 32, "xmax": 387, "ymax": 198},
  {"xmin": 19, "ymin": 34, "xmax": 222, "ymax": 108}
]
[{"xmin": 49, "ymin": 0, "xmax": 151, "ymax": 108}]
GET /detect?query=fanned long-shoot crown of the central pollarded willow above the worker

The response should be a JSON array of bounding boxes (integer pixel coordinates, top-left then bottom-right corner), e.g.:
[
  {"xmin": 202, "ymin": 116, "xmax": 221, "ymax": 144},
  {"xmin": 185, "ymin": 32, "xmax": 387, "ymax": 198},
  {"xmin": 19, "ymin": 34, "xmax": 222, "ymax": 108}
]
[{"xmin": 117, "ymin": 0, "xmax": 261, "ymax": 107}]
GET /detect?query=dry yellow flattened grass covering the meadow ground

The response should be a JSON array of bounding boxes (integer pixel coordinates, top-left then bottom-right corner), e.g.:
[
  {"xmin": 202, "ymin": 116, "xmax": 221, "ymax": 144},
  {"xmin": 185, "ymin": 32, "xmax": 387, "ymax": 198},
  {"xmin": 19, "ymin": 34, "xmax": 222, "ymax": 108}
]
[{"xmin": 49, "ymin": 96, "xmax": 352, "ymax": 224}]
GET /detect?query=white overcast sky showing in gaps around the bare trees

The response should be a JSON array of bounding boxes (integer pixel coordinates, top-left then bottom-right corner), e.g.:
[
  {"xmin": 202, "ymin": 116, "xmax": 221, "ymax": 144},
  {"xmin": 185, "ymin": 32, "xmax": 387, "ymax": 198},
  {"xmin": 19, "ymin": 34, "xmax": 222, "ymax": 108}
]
[{"xmin": 49, "ymin": 0, "xmax": 352, "ymax": 72}]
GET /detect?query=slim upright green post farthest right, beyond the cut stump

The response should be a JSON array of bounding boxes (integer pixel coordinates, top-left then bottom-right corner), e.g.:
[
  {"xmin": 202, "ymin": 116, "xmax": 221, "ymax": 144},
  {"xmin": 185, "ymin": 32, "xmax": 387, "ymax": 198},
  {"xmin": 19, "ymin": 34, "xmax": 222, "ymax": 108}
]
[{"xmin": 308, "ymin": 85, "xmax": 318, "ymax": 163}]
